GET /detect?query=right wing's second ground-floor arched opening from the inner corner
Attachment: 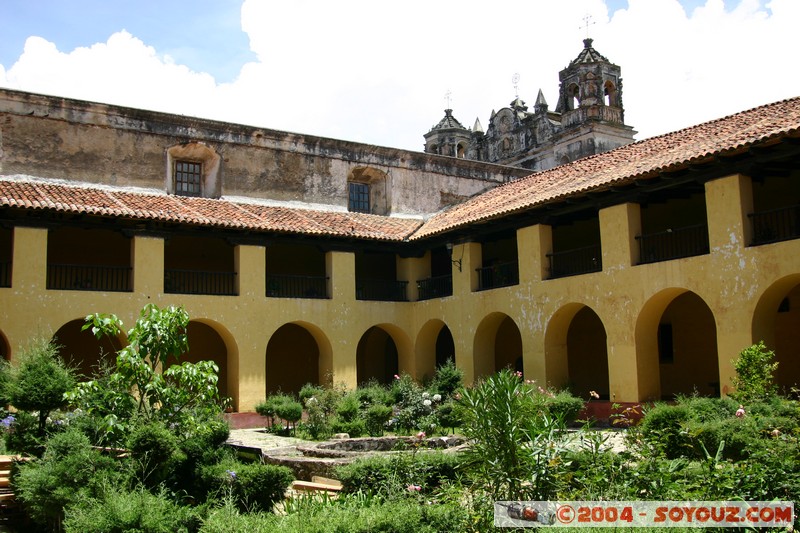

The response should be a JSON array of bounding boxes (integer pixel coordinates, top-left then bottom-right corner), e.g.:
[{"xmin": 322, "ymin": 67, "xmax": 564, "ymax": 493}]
[{"xmin": 473, "ymin": 313, "xmax": 523, "ymax": 380}]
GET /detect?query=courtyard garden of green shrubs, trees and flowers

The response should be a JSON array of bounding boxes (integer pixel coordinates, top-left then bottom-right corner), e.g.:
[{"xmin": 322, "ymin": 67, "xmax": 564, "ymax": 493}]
[{"xmin": 0, "ymin": 305, "xmax": 800, "ymax": 533}]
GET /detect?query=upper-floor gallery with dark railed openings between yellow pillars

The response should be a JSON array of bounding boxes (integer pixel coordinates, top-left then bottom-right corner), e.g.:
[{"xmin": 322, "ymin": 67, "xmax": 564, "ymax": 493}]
[{"xmin": 0, "ymin": 160, "xmax": 800, "ymax": 302}]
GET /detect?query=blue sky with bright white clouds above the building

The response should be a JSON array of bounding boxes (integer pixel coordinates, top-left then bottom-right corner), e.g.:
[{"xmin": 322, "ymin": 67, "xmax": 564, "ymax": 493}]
[{"xmin": 0, "ymin": 0, "xmax": 800, "ymax": 151}]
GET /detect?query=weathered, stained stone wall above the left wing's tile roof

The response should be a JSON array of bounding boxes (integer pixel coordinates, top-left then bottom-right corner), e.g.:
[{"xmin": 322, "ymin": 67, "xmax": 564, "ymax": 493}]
[{"xmin": 0, "ymin": 89, "xmax": 527, "ymax": 214}]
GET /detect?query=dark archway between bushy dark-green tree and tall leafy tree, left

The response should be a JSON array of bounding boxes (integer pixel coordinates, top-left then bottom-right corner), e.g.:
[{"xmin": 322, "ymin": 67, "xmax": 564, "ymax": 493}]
[{"xmin": 53, "ymin": 319, "xmax": 124, "ymax": 380}]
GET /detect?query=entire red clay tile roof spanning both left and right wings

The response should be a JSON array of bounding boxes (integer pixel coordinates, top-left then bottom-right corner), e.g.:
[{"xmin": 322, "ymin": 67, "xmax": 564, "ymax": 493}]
[{"xmin": 0, "ymin": 97, "xmax": 800, "ymax": 241}]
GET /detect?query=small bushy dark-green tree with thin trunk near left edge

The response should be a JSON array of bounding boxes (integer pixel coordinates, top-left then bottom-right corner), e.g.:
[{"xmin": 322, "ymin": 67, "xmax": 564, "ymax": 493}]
[{"xmin": 2, "ymin": 338, "xmax": 75, "ymax": 437}]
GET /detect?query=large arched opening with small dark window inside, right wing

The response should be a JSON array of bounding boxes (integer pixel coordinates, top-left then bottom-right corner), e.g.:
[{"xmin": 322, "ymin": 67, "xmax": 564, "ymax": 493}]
[{"xmin": 636, "ymin": 289, "xmax": 720, "ymax": 400}]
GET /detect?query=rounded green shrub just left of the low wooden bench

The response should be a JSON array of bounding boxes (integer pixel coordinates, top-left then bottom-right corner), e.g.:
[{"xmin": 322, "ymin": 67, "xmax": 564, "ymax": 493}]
[{"xmin": 200, "ymin": 459, "xmax": 294, "ymax": 512}]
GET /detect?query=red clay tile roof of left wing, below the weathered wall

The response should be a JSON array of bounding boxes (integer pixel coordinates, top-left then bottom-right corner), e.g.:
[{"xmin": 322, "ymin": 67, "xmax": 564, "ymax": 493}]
[{"xmin": 0, "ymin": 179, "xmax": 422, "ymax": 241}]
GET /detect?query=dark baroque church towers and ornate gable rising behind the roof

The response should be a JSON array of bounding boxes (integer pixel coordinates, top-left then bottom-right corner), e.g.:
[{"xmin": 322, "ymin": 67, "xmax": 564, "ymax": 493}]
[{"xmin": 424, "ymin": 39, "xmax": 636, "ymax": 171}]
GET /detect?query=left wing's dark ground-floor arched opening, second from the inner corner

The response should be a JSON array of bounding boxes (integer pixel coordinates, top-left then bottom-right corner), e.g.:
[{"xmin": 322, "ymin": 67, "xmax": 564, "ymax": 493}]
[{"xmin": 265, "ymin": 323, "xmax": 325, "ymax": 396}]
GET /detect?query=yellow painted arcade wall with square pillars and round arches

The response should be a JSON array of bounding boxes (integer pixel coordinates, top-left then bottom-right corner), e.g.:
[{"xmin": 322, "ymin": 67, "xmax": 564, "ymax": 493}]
[{"xmin": 0, "ymin": 172, "xmax": 800, "ymax": 411}]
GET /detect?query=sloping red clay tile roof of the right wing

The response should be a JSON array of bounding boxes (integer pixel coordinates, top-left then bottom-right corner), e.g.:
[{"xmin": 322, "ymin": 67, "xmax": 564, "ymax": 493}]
[{"xmin": 412, "ymin": 97, "xmax": 800, "ymax": 240}]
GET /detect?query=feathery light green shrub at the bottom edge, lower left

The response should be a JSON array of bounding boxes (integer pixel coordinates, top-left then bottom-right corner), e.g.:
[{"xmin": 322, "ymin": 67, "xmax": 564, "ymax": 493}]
[{"xmin": 64, "ymin": 488, "xmax": 200, "ymax": 533}]
